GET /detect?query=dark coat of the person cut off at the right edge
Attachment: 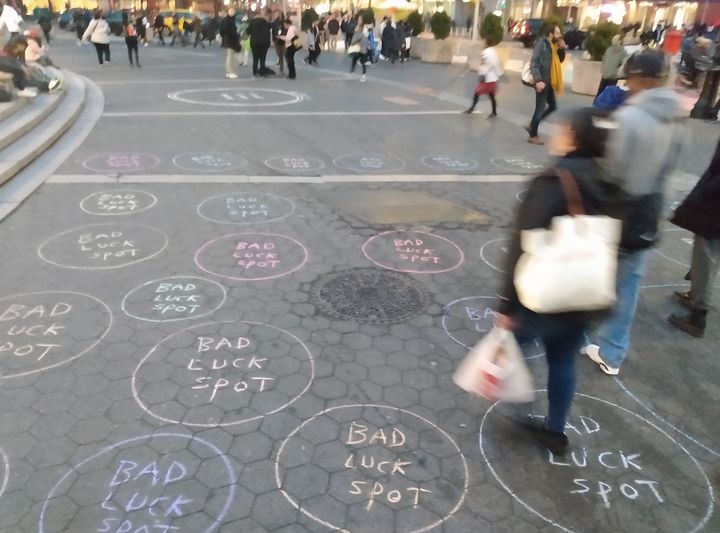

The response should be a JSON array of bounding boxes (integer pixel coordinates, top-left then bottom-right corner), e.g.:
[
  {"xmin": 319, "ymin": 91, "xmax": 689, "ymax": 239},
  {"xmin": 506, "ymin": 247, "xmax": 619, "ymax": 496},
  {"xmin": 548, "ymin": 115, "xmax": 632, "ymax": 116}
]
[{"xmin": 670, "ymin": 136, "xmax": 720, "ymax": 239}]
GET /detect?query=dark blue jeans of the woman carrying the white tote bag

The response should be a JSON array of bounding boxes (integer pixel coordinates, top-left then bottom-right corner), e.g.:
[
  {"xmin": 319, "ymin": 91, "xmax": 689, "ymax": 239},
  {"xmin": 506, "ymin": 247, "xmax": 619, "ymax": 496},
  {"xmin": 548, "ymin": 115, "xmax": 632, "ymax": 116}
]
[{"xmin": 515, "ymin": 309, "xmax": 585, "ymax": 433}]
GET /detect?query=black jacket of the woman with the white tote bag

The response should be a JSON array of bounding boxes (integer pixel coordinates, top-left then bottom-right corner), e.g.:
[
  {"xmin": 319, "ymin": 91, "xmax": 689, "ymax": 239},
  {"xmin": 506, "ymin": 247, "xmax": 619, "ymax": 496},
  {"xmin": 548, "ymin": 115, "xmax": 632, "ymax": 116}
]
[{"xmin": 499, "ymin": 154, "xmax": 624, "ymax": 323}]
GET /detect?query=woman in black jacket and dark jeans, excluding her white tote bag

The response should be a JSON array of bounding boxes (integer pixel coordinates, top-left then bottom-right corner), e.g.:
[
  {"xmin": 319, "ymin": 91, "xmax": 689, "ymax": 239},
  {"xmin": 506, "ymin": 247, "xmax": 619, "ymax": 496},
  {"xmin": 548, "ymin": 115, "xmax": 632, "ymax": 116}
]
[{"xmin": 496, "ymin": 108, "xmax": 622, "ymax": 455}]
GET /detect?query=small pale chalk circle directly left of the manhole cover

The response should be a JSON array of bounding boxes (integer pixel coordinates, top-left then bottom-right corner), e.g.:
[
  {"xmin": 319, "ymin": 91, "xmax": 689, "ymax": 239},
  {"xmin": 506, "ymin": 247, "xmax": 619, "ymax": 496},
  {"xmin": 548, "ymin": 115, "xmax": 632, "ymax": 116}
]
[{"xmin": 122, "ymin": 276, "xmax": 227, "ymax": 322}]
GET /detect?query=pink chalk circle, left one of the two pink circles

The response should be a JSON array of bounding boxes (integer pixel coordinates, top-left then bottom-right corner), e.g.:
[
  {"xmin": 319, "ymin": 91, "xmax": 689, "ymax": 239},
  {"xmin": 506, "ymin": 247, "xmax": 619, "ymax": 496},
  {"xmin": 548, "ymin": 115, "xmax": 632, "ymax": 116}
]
[{"xmin": 195, "ymin": 232, "xmax": 309, "ymax": 281}]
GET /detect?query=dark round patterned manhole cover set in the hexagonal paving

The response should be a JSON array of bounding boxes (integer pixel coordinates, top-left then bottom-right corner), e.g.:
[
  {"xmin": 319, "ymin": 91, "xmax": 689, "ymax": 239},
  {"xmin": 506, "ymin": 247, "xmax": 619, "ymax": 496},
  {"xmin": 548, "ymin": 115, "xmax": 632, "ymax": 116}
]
[{"xmin": 313, "ymin": 268, "xmax": 427, "ymax": 324}]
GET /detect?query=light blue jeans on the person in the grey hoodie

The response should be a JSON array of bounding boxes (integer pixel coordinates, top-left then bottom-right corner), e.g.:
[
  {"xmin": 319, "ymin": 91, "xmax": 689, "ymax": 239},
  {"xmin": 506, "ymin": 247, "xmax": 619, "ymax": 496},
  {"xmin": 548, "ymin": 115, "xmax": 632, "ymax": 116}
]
[{"xmin": 591, "ymin": 250, "xmax": 649, "ymax": 368}]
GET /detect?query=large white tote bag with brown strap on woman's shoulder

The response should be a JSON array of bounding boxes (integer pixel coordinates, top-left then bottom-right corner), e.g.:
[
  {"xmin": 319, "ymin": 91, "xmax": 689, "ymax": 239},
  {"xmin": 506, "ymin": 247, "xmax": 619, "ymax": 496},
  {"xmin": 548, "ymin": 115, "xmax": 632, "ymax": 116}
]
[{"xmin": 514, "ymin": 168, "xmax": 622, "ymax": 313}]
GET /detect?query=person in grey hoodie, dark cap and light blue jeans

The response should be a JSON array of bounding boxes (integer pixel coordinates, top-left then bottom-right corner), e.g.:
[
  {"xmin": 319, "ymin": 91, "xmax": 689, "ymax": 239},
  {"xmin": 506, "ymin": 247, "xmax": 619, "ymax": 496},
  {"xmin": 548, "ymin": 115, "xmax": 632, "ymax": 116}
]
[{"xmin": 581, "ymin": 50, "xmax": 683, "ymax": 376}]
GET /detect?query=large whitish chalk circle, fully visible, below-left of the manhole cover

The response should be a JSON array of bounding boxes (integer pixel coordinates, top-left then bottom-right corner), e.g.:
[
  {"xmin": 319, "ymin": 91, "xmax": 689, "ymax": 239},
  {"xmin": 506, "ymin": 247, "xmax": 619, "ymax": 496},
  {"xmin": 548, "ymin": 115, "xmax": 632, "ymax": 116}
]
[{"xmin": 131, "ymin": 321, "xmax": 315, "ymax": 428}]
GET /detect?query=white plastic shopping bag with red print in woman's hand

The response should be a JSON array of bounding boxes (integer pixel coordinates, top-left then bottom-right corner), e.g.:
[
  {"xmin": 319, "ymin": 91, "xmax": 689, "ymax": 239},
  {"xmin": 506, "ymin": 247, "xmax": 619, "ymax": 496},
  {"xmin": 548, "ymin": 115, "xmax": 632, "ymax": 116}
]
[{"xmin": 453, "ymin": 327, "xmax": 535, "ymax": 403}]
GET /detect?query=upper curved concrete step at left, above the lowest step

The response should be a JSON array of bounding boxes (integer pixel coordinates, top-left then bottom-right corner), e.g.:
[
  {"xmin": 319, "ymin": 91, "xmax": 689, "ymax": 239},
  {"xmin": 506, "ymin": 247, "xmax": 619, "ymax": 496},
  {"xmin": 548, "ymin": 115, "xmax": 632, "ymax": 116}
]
[{"xmin": 0, "ymin": 73, "xmax": 86, "ymax": 185}]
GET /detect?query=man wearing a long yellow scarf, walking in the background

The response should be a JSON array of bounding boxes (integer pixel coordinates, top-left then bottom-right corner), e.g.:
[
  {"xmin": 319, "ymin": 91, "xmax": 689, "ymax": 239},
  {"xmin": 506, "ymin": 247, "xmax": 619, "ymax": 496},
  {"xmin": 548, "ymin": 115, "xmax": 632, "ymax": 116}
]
[{"xmin": 527, "ymin": 26, "xmax": 565, "ymax": 144}]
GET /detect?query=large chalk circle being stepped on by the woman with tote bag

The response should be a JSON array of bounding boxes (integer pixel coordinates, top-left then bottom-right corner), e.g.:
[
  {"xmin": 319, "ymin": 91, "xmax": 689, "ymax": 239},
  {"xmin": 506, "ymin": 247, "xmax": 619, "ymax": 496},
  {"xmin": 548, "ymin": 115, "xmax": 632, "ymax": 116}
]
[{"xmin": 480, "ymin": 391, "xmax": 714, "ymax": 533}]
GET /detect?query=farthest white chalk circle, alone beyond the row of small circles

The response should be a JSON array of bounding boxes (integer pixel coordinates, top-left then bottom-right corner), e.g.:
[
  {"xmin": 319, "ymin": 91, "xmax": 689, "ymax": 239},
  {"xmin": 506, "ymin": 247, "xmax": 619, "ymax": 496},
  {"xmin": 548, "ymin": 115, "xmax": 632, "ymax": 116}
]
[{"xmin": 168, "ymin": 87, "xmax": 306, "ymax": 107}]
